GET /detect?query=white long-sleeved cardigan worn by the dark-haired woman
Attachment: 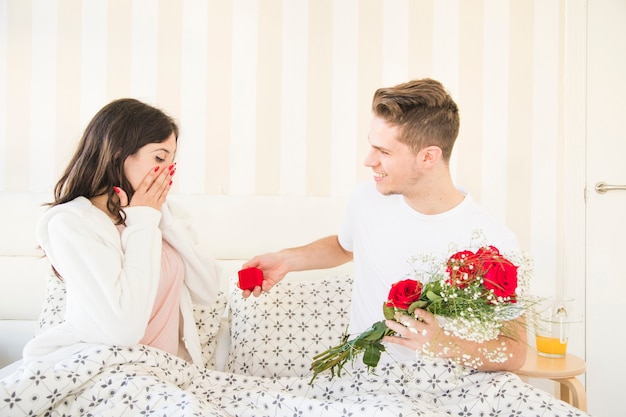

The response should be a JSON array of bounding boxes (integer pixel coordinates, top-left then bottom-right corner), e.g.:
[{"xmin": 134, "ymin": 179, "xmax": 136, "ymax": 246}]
[{"xmin": 24, "ymin": 197, "xmax": 221, "ymax": 365}]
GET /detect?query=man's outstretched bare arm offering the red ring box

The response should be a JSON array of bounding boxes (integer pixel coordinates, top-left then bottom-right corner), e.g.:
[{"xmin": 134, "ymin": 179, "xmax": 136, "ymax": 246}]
[{"xmin": 242, "ymin": 235, "xmax": 352, "ymax": 298}]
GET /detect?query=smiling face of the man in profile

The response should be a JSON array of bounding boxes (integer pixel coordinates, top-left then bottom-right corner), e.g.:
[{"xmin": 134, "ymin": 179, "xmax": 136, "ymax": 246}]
[{"xmin": 365, "ymin": 116, "xmax": 422, "ymax": 195}]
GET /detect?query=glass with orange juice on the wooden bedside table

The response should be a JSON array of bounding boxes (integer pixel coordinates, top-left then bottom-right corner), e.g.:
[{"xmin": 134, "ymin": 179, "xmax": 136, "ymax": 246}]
[{"xmin": 534, "ymin": 299, "xmax": 573, "ymax": 358}]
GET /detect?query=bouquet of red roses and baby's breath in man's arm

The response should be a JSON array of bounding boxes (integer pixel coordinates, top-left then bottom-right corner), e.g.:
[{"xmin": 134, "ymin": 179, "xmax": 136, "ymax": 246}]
[{"xmin": 310, "ymin": 246, "xmax": 530, "ymax": 383}]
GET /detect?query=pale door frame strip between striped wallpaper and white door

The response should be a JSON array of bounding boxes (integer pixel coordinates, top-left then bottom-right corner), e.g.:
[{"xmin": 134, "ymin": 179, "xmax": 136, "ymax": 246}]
[{"xmin": 556, "ymin": 0, "xmax": 593, "ymax": 358}]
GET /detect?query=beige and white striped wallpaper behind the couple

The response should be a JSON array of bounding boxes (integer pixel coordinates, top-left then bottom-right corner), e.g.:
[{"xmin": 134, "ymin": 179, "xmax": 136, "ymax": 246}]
[{"xmin": 0, "ymin": 0, "xmax": 584, "ymax": 300}]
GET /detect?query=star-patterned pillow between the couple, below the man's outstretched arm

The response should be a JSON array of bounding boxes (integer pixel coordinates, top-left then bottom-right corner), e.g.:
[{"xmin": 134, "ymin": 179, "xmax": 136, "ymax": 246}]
[{"xmin": 226, "ymin": 275, "xmax": 352, "ymax": 377}]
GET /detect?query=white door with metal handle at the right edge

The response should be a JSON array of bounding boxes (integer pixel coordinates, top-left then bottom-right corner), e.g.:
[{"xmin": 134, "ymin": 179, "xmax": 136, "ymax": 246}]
[{"xmin": 585, "ymin": 0, "xmax": 626, "ymax": 417}]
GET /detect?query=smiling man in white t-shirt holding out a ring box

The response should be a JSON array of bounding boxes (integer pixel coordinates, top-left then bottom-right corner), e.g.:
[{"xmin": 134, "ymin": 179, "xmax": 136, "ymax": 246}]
[{"xmin": 243, "ymin": 79, "xmax": 527, "ymax": 371}]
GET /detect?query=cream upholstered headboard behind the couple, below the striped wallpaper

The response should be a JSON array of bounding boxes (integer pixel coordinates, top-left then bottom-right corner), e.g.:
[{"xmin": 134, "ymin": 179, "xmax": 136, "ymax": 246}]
[{"xmin": 0, "ymin": 192, "xmax": 352, "ymax": 367}]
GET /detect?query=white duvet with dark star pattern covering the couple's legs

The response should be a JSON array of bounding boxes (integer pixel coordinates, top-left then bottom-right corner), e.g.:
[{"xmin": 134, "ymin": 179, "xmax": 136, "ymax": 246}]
[{"xmin": 0, "ymin": 345, "xmax": 586, "ymax": 417}]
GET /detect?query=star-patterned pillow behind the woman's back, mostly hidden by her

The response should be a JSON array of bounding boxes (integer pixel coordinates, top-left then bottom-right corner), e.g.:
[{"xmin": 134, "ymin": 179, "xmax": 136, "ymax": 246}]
[{"xmin": 37, "ymin": 273, "xmax": 228, "ymax": 369}]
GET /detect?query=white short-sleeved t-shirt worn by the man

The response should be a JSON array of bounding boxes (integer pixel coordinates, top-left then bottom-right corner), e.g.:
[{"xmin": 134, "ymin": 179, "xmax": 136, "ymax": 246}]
[{"xmin": 339, "ymin": 182, "xmax": 519, "ymax": 364}]
